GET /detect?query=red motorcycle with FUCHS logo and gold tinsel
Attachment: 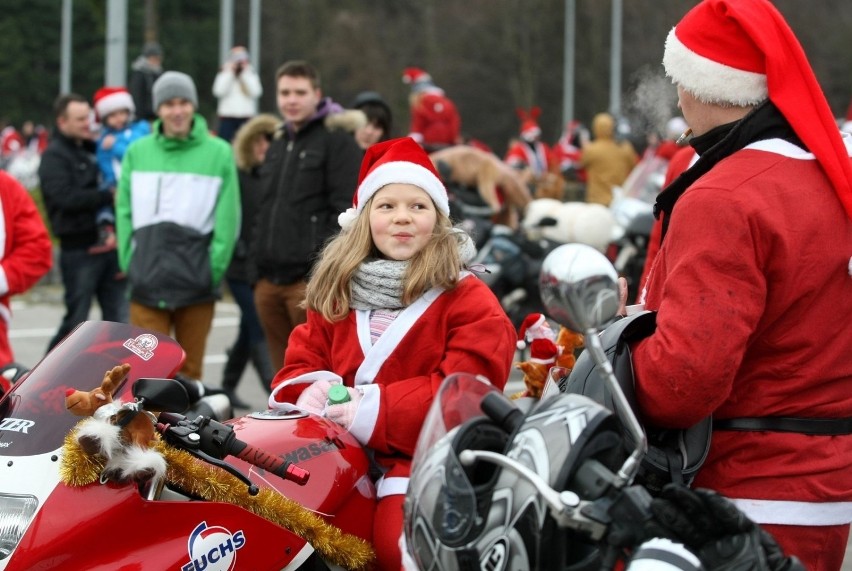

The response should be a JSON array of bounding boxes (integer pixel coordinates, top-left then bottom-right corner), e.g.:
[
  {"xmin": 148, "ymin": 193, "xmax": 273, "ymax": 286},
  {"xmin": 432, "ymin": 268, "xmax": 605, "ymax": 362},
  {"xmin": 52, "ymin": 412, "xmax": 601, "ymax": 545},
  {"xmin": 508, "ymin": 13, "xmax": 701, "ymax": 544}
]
[{"xmin": 0, "ymin": 321, "xmax": 375, "ymax": 571}]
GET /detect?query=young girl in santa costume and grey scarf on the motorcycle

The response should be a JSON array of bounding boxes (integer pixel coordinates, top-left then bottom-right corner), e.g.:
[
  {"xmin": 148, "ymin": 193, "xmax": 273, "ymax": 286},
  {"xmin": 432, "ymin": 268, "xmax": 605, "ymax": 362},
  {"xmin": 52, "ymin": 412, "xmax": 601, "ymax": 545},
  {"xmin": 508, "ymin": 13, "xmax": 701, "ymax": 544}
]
[{"xmin": 269, "ymin": 137, "xmax": 516, "ymax": 569}]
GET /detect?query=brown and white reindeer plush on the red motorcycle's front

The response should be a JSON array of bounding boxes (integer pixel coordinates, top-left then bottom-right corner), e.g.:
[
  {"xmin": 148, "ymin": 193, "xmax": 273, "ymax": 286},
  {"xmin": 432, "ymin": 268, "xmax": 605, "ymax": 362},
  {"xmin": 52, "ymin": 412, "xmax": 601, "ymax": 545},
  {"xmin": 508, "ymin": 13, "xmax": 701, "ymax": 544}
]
[{"xmin": 65, "ymin": 363, "xmax": 166, "ymax": 480}]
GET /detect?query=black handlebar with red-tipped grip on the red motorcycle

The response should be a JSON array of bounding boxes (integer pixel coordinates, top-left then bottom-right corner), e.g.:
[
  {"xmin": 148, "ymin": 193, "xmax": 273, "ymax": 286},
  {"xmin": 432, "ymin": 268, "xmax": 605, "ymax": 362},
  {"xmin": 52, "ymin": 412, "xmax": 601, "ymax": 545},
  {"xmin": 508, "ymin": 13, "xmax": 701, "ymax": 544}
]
[{"xmin": 157, "ymin": 412, "xmax": 310, "ymax": 486}]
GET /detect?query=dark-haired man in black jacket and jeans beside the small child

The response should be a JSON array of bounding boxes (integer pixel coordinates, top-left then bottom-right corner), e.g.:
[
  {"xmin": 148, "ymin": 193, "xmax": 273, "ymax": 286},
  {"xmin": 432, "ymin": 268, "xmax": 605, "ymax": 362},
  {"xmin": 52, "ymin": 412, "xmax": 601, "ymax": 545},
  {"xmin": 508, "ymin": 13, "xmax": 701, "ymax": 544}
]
[{"xmin": 38, "ymin": 93, "xmax": 127, "ymax": 350}]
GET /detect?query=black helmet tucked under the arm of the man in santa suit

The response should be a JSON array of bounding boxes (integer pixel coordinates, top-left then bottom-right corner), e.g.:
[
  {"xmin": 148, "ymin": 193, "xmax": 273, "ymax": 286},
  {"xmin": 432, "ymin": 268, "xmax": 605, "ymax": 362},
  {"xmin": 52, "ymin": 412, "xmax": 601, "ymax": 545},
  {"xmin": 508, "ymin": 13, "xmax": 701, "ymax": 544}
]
[{"xmin": 560, "ymin": 311, "xmax": 712, "ymax": 493}]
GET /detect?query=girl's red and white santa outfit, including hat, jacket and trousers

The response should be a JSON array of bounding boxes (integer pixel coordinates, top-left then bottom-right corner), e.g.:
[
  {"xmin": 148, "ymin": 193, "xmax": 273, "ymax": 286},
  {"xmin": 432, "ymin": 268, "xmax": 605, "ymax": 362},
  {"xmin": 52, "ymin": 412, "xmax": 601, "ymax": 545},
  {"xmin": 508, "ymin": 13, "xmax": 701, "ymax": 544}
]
[{"xmin": 269, "ymin": 139, "xmax": 516, "ymax": 568}]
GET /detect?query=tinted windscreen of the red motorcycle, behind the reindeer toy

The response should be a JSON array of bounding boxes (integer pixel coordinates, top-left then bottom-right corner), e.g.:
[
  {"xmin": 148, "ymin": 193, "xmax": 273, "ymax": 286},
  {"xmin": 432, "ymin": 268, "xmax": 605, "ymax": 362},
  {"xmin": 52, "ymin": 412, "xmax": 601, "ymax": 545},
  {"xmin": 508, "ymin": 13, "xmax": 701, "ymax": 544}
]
[{"xmin": 0, "ymin": 321, "xmax": 186, "ymax": 456}]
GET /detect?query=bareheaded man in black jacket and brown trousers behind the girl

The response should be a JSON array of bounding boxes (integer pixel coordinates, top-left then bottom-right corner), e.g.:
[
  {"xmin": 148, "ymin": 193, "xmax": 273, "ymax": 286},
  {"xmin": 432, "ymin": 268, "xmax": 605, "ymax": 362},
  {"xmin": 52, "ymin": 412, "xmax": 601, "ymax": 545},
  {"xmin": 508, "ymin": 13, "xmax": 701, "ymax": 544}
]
[{"xmin": 253, "ymin": 61, "xmax": 363, "ymax": 370}]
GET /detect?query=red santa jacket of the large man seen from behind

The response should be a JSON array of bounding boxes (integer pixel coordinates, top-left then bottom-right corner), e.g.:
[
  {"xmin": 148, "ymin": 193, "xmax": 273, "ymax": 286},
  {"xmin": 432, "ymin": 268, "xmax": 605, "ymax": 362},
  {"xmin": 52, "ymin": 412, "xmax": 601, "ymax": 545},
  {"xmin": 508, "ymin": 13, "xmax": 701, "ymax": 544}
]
[{"xmin": 633, "ymin": 136, "xmax": 852, "ymax": 525}]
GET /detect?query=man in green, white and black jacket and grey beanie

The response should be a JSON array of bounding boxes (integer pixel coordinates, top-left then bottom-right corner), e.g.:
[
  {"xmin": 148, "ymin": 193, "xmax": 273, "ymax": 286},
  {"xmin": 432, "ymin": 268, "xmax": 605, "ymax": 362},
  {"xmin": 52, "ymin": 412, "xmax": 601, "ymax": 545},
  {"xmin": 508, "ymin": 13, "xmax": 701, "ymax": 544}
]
[{"xmin": 116, "ymin": 71, "xmax": 240, "ymax": 379}]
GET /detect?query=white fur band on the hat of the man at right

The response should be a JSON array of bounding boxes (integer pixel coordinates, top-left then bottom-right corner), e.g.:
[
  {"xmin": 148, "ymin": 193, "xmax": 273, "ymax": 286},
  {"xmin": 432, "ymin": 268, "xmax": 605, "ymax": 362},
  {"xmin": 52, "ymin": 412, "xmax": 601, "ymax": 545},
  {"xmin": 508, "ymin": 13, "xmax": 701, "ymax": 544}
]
[{"xmin": 663, "ymin": 28, "xmax": 769, "ymax": 106}]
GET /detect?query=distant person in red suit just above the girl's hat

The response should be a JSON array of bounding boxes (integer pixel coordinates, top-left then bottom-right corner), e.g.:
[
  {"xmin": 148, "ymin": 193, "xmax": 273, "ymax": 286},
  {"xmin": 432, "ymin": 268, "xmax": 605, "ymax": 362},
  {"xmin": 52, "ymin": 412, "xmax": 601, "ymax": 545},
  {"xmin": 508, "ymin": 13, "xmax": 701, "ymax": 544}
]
[{"xmin": 402, "ymin": 67, "xmax": 463, "ymax": 153}]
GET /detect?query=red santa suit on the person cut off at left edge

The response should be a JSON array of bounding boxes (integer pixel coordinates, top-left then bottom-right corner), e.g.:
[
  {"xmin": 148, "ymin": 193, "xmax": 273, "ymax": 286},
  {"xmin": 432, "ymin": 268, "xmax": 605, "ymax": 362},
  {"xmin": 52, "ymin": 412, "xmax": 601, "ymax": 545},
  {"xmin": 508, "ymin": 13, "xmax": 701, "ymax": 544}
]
[{"xmin": 0, "ymin": 171, "xmax": 53, "ymax": 380}]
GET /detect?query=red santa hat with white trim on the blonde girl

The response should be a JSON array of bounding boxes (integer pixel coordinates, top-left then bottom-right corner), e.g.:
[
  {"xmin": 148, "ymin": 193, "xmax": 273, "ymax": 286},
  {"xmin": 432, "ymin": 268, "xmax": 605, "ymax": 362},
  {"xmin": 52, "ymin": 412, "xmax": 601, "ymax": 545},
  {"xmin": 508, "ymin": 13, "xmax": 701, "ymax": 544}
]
[{"xmin": 337, "ymin": 137, "xmax": 450, "ymax": 230}]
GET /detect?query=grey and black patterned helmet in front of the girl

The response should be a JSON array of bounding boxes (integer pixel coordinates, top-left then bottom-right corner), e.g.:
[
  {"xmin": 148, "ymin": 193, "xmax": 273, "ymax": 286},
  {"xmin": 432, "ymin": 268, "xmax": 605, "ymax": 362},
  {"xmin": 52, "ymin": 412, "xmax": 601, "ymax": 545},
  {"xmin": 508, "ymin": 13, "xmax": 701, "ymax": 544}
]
[{"xmin": 405, "ymin": 386, "xmax": 626, "ymax": 571}]
